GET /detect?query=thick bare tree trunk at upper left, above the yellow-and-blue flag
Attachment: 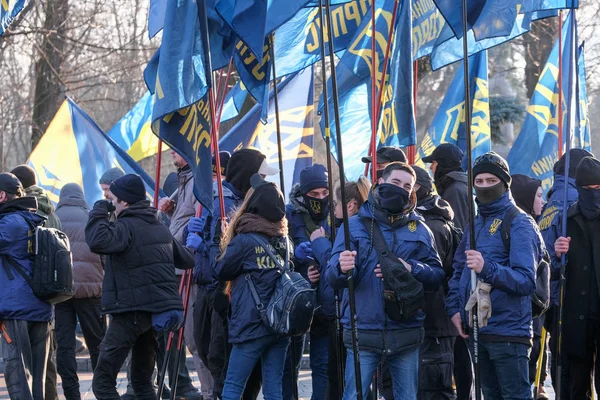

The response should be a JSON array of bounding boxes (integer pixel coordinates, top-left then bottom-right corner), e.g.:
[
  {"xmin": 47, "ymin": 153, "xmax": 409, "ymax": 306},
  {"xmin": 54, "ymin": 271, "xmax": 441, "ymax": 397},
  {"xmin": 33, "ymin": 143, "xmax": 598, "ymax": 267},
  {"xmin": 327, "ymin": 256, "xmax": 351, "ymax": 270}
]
[{"xmin": 31, "ymin": 0, "xmax": 69, "ymax": 150}]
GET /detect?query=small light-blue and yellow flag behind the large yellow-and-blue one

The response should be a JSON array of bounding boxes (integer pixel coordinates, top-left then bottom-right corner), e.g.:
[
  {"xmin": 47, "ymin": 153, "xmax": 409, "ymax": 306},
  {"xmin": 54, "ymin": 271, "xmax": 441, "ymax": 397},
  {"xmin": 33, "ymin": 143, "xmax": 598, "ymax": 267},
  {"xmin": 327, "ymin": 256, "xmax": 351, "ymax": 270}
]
[{"xmin": 107, "ymin": 92, "xmax": 168, "ymax": 162}]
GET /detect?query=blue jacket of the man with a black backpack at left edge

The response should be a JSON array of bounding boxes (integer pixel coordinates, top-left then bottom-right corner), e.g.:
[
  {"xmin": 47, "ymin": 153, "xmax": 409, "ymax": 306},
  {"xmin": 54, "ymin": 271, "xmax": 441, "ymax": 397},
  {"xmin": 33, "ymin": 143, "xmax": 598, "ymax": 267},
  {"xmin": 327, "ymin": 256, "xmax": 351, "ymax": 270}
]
[{"xmin": 0, "ymin": 197, "xmax": 52, "ymax": 322}]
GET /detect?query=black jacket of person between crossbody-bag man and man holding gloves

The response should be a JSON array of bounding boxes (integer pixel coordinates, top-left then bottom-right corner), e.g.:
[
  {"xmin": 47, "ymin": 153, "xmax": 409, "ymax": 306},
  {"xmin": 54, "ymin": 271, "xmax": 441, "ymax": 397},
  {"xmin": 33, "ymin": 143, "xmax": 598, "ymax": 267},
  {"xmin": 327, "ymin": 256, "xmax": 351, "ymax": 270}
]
[{"xmin": 417, "ymin": 195, "xmax": 458, "ymax": 337}]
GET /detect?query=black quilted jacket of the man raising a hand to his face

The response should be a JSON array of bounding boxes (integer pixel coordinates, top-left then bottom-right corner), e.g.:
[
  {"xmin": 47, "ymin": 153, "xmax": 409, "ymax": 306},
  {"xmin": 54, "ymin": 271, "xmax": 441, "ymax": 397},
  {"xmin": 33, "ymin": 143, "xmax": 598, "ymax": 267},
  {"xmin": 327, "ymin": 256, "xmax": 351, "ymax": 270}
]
[{"xmin": 85, "ymin": 200, "xmax": 194, "ymax": 314}]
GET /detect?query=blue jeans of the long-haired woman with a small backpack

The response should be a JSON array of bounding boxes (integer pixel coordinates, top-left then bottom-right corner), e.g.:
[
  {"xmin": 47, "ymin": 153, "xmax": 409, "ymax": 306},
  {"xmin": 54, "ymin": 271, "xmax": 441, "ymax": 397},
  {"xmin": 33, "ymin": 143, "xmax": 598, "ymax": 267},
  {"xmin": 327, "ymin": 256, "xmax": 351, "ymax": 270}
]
[{"xmin": 222, "ymin": 336, "xmax": 290, "ymax": 400}]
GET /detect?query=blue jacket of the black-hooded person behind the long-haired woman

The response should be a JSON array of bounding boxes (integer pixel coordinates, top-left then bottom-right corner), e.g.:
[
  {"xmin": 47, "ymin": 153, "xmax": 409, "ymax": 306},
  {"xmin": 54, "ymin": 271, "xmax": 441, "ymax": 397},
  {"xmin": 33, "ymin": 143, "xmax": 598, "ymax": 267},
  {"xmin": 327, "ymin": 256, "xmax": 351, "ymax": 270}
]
[{"xmin": 190, "ymin": 182, "xmax": 234, "ymax": 289}]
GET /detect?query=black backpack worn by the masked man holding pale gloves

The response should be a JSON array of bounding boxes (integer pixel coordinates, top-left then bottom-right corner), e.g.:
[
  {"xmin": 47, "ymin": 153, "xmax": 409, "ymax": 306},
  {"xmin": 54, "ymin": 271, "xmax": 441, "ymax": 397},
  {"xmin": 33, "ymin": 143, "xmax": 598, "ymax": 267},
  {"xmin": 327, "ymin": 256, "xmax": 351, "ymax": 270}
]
[{"xmin": 500, "ymin": 207, "xmax": 550, "ymax": 318}]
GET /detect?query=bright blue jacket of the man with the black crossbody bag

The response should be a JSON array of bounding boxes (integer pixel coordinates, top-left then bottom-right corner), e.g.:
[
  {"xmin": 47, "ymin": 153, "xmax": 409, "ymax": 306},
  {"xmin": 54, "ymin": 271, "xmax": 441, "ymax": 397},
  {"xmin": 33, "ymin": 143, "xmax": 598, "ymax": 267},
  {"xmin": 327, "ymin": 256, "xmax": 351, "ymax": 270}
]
[{"xmin": 326, "ymin": 201, "xmax": 445, "ymax": 331}]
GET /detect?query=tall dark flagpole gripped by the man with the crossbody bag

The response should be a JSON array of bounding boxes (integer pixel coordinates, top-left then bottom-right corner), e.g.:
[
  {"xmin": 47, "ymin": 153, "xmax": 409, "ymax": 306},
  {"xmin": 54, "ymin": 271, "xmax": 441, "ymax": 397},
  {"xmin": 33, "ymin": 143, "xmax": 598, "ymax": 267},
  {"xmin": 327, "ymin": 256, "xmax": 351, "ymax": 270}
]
[{"xmin": 325, "ymin": 0, "xmax": 363, "ymax": 400}]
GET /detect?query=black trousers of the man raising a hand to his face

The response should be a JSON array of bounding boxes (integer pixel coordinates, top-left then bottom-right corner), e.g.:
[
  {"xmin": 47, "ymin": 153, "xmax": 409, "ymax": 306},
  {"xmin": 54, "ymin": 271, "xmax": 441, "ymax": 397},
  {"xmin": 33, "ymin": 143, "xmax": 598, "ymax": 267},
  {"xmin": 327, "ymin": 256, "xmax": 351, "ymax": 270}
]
[{"xmin": 92, "ymin": 312, "xmax": 157, "ymax": 400}]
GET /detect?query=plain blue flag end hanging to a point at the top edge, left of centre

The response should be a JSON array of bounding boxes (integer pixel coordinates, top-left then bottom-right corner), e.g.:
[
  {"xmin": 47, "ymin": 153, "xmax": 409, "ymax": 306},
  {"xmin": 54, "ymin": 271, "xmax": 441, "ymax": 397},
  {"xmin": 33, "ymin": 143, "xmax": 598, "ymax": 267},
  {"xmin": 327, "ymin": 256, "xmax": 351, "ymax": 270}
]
[{"xmin": 216, "ymin": 0, "xmax": 308, "ymax": 58}]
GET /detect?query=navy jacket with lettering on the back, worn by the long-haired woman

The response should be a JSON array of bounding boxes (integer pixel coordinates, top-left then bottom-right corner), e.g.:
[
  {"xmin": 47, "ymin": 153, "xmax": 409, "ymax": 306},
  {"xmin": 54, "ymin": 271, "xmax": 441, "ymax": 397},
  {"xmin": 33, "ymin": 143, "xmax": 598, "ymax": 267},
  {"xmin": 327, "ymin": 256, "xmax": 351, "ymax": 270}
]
[{"xmin": 215, "ymin": 233, "xmax": 286, "ymax": 343}]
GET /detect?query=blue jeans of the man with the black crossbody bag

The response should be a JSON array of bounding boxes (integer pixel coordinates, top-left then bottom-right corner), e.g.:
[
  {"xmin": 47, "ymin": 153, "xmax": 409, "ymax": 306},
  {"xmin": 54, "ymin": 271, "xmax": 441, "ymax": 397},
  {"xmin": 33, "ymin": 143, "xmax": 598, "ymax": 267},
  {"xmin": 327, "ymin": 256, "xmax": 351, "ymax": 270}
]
[{"xmin": 343, "ymin": 347, "xmax": 419, "ymax": 400}]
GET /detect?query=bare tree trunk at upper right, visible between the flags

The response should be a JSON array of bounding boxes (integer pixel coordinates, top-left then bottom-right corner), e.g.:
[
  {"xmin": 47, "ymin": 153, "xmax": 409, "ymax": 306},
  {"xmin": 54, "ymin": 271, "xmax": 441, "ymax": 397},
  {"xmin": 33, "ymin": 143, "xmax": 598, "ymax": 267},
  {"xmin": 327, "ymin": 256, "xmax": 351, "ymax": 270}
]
[{"xmin": 523, "ymin": 18, "xmax": 558, "ymax": 99}]
